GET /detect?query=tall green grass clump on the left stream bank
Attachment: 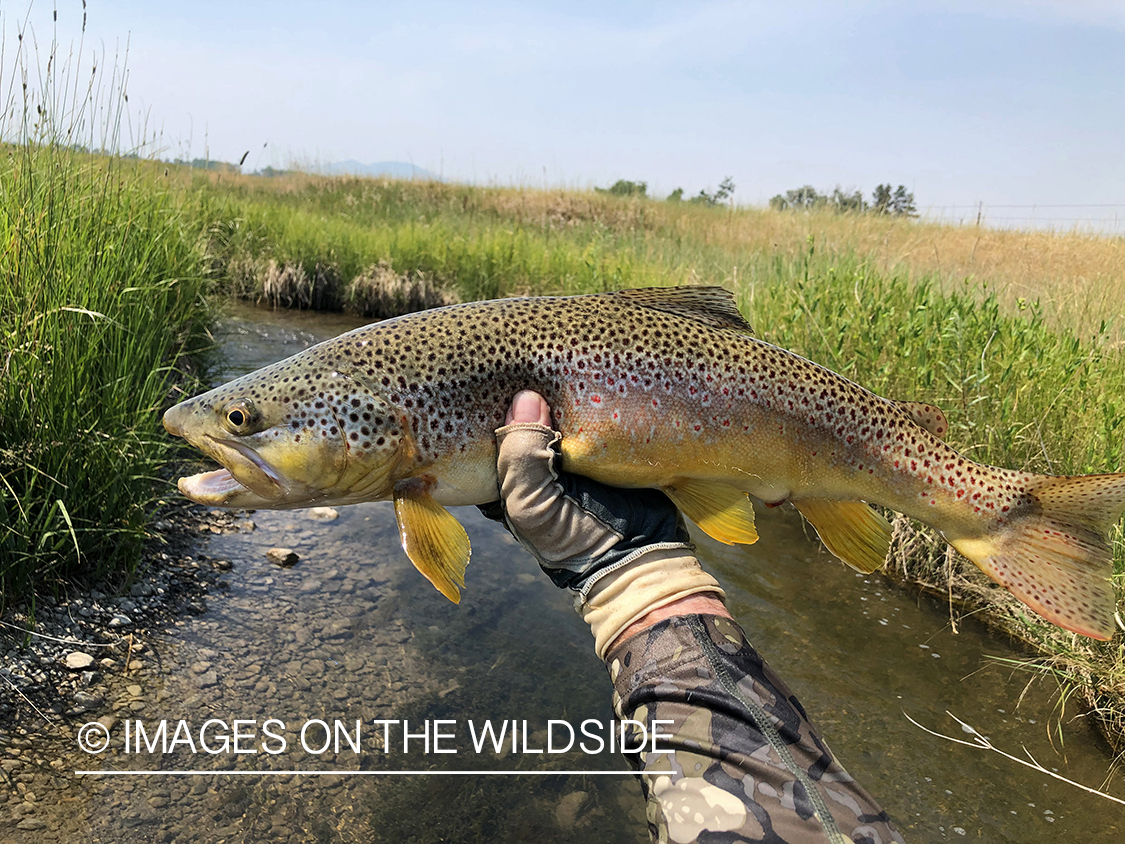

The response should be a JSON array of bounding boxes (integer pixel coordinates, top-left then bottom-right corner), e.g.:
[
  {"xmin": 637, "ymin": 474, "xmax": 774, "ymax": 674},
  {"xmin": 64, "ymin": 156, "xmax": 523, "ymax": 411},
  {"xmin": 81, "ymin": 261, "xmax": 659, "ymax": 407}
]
[{"xmin": 0, "ymin": 16, "xmax": 207, "ymax": 603}]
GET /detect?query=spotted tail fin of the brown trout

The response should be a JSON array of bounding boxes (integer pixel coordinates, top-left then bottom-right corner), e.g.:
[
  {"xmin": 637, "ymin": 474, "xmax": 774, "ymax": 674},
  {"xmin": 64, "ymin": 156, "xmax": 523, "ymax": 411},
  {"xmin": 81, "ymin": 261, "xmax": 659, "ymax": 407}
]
[{"xmin": 947, "ymin": 474, "xmax": 1125, "ymax": 639}]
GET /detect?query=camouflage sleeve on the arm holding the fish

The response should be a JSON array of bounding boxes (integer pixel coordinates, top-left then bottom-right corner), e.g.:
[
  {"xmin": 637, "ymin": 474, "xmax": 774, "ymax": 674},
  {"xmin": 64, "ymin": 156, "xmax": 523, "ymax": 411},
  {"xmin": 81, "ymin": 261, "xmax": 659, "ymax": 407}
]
[{"xmin": 605, "ymin": 616, "xmax": 902, "ymax": 844}]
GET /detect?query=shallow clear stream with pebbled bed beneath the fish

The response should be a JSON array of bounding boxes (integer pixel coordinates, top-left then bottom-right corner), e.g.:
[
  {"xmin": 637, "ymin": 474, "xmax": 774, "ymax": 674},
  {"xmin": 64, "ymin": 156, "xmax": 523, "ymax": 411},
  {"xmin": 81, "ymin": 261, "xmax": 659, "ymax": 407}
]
[{"xmin": 0, "ymin": 307, "xmax": 1125, "ymax": 844}]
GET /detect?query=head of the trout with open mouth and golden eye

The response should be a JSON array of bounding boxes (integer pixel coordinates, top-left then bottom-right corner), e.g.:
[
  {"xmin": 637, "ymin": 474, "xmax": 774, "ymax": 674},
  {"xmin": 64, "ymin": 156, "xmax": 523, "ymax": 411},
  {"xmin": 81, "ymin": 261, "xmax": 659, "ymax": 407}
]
[{"xmin": 164, "ymin": 353, "xmax": 411, "ymax": 510}]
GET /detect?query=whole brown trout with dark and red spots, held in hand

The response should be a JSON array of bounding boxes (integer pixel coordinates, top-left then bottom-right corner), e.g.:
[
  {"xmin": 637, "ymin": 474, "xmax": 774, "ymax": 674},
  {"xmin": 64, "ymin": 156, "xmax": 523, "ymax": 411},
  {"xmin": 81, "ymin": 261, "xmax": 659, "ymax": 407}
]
[{"xmin": 164, "ymin": 287, "xmax": 1125, "ymax": 639}]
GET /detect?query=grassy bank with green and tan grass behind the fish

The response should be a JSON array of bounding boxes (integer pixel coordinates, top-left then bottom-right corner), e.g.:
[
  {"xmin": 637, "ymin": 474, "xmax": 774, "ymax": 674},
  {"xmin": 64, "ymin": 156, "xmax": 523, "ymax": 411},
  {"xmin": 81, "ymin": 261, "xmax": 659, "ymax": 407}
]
[{"xmin": 196, "ymin": 169, "xmax": 1125, "ymax": 747}]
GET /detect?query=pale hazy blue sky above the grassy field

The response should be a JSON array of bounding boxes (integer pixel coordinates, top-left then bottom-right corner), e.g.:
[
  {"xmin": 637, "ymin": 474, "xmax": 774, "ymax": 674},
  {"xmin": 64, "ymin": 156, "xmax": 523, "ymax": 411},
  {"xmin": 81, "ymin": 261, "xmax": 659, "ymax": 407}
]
[{"xmin": 8, "ymin": 0, "xmax": 1125, "ymax": 217}]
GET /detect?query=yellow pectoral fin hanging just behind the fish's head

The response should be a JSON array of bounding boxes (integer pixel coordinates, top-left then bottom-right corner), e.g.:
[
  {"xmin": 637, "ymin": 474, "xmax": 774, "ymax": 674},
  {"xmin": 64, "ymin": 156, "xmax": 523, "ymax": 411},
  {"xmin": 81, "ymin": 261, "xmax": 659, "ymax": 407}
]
[{"xmin": 395, "ymin": 479, "xmax": 470, "ymax": 603}]
